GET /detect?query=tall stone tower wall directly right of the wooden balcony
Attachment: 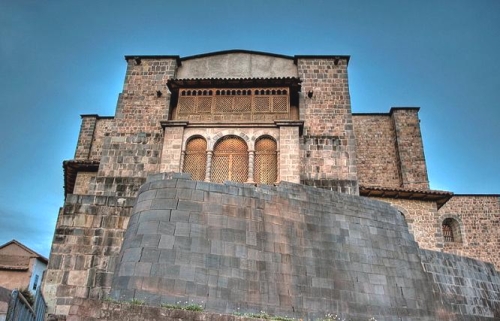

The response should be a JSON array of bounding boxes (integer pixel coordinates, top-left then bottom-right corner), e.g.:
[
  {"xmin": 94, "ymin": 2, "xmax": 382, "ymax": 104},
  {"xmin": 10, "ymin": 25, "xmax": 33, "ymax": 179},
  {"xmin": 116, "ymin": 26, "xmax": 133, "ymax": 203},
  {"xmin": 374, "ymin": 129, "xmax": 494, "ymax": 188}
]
[{"xmin": 297, "ymin": 57, "xmax": 358, "ymax": 194}]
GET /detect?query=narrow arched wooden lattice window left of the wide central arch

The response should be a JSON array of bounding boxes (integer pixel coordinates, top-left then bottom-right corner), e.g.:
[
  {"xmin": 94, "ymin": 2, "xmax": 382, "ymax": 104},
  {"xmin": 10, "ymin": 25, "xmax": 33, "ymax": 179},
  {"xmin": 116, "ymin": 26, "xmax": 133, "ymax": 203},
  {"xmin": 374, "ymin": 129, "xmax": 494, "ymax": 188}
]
[{"xmin": 182, "ymin": 137, "xmax": 207, "ymax": 181}]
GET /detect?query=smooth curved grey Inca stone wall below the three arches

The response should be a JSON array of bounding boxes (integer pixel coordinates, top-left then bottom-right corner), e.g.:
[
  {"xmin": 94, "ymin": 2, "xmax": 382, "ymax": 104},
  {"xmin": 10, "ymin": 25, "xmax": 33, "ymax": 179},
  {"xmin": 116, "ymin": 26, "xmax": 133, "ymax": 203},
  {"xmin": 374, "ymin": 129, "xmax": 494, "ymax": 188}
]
[{"xmin": 111, "ymin": 174, "xmax": 499, "ymax": 320}]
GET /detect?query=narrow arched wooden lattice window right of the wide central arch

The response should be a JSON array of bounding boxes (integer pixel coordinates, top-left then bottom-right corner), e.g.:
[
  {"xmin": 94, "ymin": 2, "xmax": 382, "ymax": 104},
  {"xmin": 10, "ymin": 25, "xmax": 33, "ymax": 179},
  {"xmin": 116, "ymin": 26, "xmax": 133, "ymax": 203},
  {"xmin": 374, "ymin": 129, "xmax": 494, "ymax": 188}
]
[{"xmin": 253, "ymin": 137, "xmax": 278, "ymax": 184}]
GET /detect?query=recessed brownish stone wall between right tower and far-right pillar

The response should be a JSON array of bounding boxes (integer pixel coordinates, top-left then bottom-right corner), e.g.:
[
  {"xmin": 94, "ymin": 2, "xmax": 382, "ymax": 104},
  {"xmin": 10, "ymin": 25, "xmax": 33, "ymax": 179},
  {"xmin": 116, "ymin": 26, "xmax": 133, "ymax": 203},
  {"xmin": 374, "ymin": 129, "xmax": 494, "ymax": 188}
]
[{"xmin": 353, "ymin": 114, "xmax": 402, "ymax": 188}]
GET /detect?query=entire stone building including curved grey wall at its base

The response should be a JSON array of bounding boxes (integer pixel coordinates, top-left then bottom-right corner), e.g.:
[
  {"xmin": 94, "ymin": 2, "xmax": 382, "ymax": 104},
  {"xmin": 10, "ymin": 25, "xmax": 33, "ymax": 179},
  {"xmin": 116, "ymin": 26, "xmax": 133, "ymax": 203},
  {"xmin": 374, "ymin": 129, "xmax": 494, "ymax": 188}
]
[{"xmin": 44, "ymin": 50, "xmax": 500, "ymax": 320}]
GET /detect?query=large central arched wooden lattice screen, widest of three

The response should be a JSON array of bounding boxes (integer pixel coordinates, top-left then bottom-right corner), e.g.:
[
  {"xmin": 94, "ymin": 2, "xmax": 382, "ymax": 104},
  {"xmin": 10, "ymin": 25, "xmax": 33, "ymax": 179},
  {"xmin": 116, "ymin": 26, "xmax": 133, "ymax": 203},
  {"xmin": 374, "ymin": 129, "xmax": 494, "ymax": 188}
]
[{"xmin": 210, "ymin": 136, "xmax": 248, "ymax": 183}]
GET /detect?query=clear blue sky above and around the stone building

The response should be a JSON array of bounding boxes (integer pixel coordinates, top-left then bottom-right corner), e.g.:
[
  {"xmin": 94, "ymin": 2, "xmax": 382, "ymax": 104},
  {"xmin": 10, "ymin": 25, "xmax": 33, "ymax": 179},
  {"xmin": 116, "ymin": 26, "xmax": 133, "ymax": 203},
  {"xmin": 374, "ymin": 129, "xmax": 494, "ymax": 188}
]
[{"xmin": 0, "ymin": 0, "xmax": 500, "ymax": 256}]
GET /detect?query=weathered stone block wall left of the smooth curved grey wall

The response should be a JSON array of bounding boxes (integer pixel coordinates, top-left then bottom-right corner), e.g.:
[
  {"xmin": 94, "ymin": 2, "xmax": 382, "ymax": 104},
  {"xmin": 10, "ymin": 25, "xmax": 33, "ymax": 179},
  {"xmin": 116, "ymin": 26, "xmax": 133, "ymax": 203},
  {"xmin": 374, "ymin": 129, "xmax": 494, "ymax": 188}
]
[{"xmin": 43, "ymin": 194, "xmax": 134, "ymax": 315}]
